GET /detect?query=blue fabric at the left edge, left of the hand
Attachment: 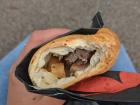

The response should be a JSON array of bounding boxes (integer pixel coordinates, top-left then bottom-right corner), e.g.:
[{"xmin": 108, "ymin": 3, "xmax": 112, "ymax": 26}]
[{"xmin": 0, "ymin": 37, "xmax": 28, "ymax": 105}]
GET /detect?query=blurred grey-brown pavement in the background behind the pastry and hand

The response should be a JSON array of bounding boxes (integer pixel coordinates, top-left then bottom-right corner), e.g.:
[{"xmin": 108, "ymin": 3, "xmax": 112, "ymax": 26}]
[{"xmin": 0, "ymin": 0, "xmax": 140, "ymax": 71}]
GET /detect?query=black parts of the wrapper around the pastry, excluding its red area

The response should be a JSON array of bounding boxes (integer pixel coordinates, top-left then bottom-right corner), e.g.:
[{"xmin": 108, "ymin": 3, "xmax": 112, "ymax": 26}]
[{"xmin": 15, "ymin": 12, "xmax": 140, "ymax": 105}]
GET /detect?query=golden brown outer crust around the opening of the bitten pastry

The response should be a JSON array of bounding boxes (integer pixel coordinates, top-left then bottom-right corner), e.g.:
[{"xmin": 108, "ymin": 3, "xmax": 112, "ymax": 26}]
[{"xmin": 28, "ymin": 28, "xmax": 120, "ymax": 88}]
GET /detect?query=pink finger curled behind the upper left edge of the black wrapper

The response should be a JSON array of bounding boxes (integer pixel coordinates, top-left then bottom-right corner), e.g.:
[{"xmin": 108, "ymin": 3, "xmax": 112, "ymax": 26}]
[{"xmin": 16, "ymin": 28, "xmax": 70, "ymax": 64}]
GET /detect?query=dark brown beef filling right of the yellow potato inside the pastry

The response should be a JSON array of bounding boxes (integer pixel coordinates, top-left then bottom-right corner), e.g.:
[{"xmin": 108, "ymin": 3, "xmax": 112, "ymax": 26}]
[{"xmin": 62, "ymin": 48, "xmax": 96, "ymax": 76}]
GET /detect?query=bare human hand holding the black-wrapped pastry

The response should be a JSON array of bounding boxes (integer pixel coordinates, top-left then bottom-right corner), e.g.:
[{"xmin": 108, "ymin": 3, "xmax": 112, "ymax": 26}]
[{"xmin": 7, "ymin": 28, "xmax": 70, "ymax": 105}]
